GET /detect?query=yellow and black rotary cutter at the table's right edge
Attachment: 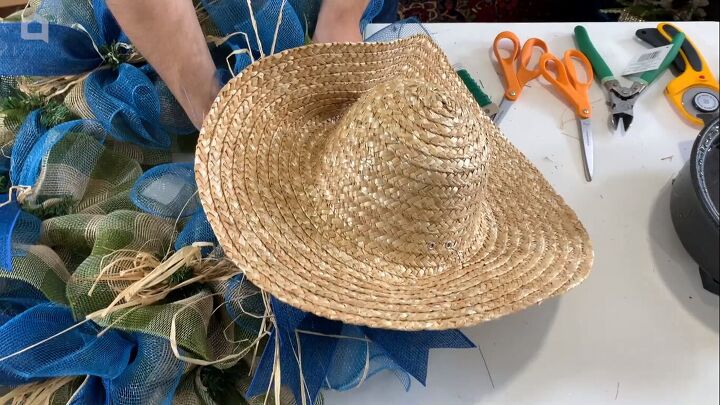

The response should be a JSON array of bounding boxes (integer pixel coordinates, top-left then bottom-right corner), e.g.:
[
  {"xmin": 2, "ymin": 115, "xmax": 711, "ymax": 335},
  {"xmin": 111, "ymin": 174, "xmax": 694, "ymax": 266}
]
[{"xmin": 636, "ymin": 23, "xmax": 720, "ymax": 127}]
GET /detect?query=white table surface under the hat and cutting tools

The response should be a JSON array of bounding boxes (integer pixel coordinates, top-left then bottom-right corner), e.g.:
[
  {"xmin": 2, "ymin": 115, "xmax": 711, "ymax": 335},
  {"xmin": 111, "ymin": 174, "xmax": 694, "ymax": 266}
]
[{"xmin": 325, "ymin": 22, "xmax": 719, "ymax": 404}]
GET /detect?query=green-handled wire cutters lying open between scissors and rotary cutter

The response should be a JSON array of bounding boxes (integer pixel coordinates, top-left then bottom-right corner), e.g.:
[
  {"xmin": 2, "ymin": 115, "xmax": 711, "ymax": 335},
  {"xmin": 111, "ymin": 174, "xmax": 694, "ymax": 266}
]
[{"xmin": 575, "ymin": 25, "xmax": 685, "ymax": 135}]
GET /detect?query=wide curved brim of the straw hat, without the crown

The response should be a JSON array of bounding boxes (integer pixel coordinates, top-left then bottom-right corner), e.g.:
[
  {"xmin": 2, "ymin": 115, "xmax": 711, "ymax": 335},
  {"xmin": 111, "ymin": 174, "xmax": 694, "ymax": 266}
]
[{"xmin": 195, "ymin": 37, "xmax": 593, "ymax": 330}]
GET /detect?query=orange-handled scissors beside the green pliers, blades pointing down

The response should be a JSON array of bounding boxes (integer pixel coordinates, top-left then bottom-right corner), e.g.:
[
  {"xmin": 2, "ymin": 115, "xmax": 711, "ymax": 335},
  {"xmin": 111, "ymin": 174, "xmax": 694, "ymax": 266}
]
[{"xmin": 540, "ymin": 49, "xmax": 594, "ymax": 181}]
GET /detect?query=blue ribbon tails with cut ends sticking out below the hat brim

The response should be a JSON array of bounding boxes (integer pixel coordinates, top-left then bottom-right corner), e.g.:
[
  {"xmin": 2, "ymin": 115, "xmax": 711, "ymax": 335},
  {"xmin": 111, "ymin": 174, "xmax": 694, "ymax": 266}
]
[{"xmin": 247, "ymin": 298, "xmax": 475, "ymax": 404}]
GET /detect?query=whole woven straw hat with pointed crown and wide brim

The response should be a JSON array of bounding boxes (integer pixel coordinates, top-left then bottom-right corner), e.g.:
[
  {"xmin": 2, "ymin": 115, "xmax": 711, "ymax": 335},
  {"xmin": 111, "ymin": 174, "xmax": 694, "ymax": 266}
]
[{"xmin": 195, "ymin": 36, "xmax": 593, "ymax": 330}]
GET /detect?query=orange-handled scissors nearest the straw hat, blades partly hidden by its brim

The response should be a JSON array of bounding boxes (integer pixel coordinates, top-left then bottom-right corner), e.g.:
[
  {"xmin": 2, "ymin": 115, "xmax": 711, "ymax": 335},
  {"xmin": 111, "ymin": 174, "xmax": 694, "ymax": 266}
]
[{"xmin": 493, "ymin": 31, "xmax": 548, "ymax": 124}]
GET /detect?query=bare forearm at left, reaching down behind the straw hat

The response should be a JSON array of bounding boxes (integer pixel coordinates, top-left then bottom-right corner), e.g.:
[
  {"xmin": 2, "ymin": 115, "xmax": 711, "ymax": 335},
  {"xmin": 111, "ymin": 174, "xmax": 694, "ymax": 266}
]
[{"xmin": 107, "ymin": 0, "xmax": 219, "ymax": 127}]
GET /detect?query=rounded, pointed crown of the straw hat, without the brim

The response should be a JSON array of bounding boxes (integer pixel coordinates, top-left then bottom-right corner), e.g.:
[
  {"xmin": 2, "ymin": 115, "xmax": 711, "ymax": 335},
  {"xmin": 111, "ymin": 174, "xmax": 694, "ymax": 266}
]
[{"xmin": 315, "ymin": 78, "xmax": 488, "ymax": 272}]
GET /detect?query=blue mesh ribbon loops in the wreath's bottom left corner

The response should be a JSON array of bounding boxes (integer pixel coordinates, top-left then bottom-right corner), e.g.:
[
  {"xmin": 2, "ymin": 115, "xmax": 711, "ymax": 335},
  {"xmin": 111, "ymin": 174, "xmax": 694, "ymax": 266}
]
[{"xmin": 0, "ymin": 300, "xmax": 185, "ymax": 405}]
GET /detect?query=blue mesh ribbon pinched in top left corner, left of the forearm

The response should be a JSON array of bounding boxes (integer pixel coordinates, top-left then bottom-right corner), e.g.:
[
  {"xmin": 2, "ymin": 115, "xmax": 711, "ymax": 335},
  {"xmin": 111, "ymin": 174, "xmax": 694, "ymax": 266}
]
[{"xmin": 0, "ymin": 0, "xmax": 191, "ymax": 148}]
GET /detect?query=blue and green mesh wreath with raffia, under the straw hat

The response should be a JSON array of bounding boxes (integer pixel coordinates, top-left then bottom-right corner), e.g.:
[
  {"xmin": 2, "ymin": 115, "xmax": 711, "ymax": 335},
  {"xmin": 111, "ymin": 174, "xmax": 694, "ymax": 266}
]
[{"xmin": 0, "ymin": 0, "xmax": 473, "ymax": 404}]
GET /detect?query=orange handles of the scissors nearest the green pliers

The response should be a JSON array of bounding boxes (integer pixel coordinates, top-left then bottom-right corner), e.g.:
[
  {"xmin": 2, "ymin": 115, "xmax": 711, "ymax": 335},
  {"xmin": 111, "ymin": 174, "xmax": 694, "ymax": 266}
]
[{"xmin": 540, "ymin": 49, "xmax": 593, "ymax": 118}]
